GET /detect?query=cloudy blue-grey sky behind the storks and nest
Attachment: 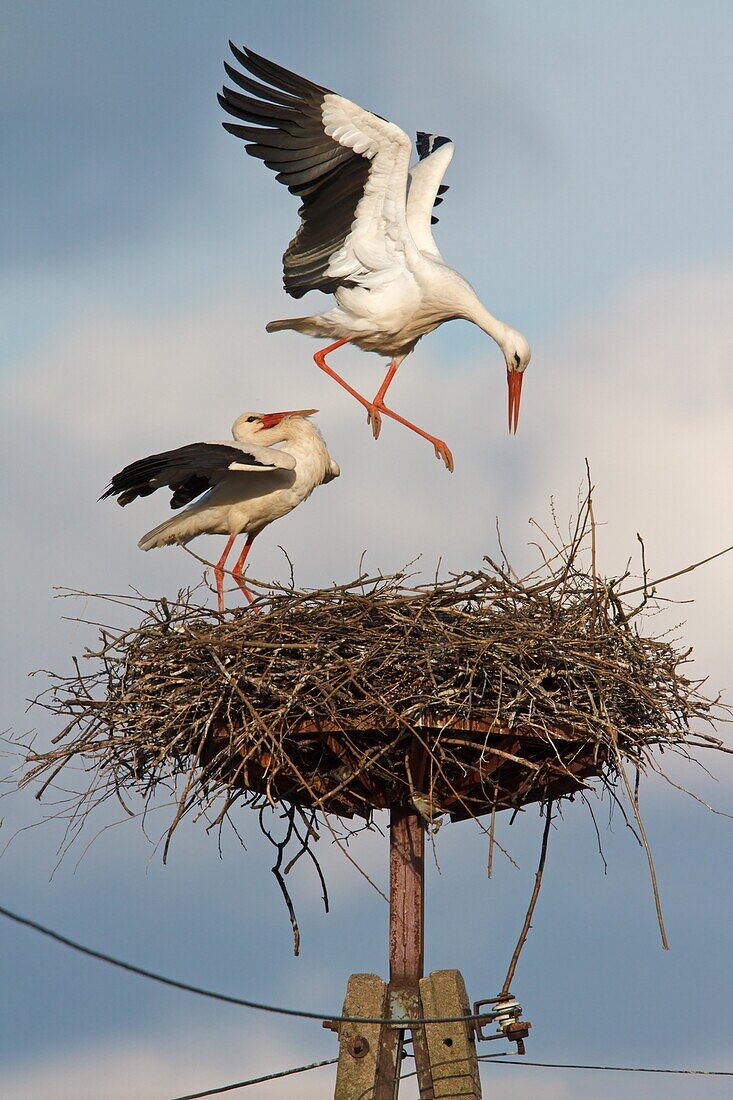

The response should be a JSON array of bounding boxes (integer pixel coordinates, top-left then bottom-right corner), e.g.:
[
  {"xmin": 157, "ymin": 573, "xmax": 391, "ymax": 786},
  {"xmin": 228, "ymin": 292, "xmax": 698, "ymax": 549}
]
[{"xmin": 0, "ymin": 0, "xmax": 733, "ymax": 1100}]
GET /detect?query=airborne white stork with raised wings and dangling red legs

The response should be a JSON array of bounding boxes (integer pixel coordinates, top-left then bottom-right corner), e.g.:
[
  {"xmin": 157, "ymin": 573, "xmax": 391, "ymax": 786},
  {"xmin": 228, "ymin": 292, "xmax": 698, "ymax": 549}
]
[{"xmin": 219, "ymin": 43, "xmax": 530, "ymax": 470}]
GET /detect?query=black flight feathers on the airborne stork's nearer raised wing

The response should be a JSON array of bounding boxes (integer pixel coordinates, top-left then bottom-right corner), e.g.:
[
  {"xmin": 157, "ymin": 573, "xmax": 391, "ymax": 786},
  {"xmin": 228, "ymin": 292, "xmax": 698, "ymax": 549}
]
[{"xmin": 219, "ymin": 42, "xmax": 370, "ymax": 298}]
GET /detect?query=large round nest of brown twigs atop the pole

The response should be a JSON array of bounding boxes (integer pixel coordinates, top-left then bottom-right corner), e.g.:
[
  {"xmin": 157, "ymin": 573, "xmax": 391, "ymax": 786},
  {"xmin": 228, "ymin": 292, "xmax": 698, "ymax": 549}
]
[{"xmin": 25, "ymin": 550, "xmax": 720, "ymax": 827}]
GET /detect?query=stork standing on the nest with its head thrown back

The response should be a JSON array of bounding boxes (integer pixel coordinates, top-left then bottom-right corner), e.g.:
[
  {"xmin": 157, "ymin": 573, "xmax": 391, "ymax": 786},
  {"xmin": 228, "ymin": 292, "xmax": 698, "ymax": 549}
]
[{"xmin": 100, "ymin": 409, "xmax": 341, "ymax": 612}]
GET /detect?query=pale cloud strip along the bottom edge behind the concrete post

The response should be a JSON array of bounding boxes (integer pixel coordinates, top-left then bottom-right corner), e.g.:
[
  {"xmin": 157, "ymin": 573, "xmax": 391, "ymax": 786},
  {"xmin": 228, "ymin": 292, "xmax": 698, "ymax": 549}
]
[{"xmin": 0, "ymin": 1025, "xmax": 730, "ymax": 1100}]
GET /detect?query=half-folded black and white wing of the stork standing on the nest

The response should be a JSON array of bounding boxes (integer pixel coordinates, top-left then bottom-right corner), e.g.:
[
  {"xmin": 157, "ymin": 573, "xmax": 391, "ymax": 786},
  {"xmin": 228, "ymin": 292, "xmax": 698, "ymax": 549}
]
[{"xmin": 100, "ymin": 442, "xmax": 295, "ymax": 508}]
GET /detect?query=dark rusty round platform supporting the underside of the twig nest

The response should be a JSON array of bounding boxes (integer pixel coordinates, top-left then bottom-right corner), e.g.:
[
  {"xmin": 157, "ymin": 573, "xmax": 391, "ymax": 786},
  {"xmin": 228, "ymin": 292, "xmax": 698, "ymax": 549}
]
[{"xmin": 198, "ymin": 715, "xmax": 608, "ymax": 821}]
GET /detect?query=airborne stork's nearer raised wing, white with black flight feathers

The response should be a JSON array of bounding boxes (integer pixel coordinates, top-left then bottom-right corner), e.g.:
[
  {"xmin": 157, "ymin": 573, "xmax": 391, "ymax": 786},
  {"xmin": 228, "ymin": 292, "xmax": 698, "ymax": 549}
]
[{"xmin": 219, "ymin": 43, "xmax": 412, "ymax": 298}]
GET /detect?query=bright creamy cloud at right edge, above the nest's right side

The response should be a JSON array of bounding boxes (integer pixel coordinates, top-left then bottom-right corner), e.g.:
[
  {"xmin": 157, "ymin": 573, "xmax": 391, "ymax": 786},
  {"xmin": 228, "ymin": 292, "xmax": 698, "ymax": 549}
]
[{"xmin": 529, "ymin": 268, "xmax": 733, "ymax": 704}]
